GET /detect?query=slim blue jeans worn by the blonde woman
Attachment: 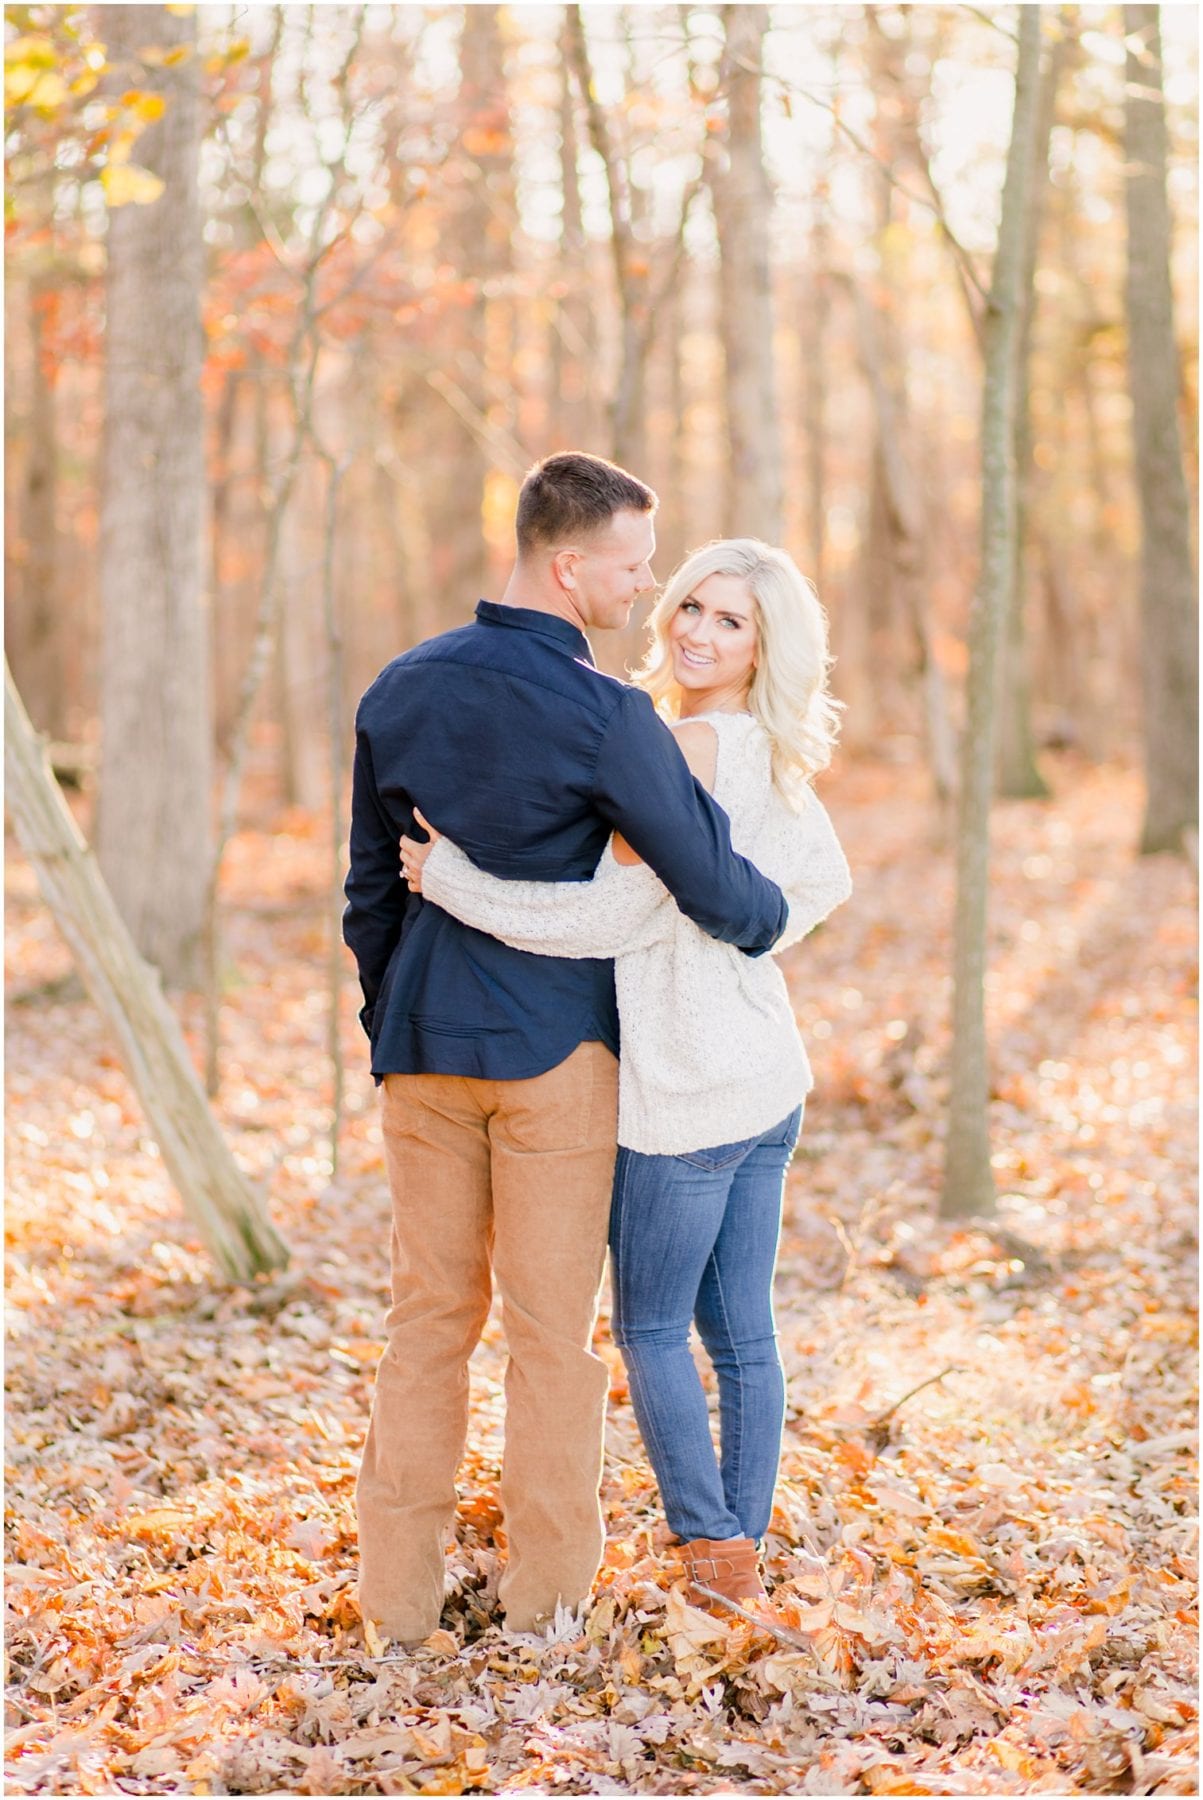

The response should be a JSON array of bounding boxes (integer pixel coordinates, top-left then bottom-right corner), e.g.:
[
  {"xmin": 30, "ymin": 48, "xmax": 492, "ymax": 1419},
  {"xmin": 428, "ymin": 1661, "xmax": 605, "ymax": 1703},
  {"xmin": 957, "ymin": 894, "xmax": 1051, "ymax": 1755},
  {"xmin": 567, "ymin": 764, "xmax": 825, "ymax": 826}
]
[{"xmin": 611, "ymin": 1107, "xmax": 801, "ymax": 1543}]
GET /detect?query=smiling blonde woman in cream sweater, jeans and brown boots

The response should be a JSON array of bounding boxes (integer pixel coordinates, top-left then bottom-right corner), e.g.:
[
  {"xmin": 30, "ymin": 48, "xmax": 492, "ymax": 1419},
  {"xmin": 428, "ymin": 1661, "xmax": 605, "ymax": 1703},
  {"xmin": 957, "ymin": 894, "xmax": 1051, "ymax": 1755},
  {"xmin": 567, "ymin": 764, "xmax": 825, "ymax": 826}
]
[{"xmin": 402, "ymin": 538, "xmax": 850, "ymax": 1606}]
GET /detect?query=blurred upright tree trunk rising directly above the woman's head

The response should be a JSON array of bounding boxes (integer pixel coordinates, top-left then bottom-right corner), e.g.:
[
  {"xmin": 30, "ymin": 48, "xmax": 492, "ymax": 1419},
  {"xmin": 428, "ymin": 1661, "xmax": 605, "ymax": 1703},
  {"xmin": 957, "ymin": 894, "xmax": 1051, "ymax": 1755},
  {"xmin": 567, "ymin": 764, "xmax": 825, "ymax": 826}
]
[{"xmin": 710, "ymin": 5, "xmax": 782, "ymax": 544}]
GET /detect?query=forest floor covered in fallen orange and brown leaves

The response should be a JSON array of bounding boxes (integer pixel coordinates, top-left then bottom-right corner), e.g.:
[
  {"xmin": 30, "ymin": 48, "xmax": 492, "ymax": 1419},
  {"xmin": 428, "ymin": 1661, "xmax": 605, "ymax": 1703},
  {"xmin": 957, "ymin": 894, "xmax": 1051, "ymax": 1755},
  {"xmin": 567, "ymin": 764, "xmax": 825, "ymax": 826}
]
[{"xmin": 7, "ymin": 761, "xmax": 1198, "ymax": 1795}]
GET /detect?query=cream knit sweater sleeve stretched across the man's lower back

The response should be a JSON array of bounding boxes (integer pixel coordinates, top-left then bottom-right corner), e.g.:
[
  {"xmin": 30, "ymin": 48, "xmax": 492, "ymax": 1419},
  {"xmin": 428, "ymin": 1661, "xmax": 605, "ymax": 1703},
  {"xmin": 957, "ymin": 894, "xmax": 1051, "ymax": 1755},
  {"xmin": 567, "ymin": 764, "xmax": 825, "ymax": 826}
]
[{"xmin": 421, "ymin": 837, "xmax": 677, "ymax": 959}]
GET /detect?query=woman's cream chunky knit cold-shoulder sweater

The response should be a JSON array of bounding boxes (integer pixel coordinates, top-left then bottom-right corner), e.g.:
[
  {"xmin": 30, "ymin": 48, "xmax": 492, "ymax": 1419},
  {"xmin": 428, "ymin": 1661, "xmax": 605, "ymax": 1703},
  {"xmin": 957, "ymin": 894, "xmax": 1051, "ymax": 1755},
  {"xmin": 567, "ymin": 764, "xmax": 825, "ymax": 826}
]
[{"xmin": 421, "ymin": 713, "xmax": 852, "ymax": 1156}]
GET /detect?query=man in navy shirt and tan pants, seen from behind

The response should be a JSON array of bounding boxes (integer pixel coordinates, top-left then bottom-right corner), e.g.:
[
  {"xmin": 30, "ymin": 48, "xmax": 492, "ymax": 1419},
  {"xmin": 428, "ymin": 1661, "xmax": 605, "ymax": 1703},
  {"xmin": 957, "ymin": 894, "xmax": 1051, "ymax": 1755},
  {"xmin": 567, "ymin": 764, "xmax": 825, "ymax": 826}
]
[{"xmin": 344, "ymin": 452, "xmax": 785, "ymax": 1643}]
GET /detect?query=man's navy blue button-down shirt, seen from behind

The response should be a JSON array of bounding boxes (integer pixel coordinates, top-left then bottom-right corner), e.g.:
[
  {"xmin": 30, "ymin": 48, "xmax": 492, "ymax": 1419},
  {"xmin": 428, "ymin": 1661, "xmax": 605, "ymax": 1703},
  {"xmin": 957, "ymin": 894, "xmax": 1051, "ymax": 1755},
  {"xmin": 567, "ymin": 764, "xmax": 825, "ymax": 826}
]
[{"xmin": 344, "ymin": 599, "xmax": 787, "ymax": 1080}]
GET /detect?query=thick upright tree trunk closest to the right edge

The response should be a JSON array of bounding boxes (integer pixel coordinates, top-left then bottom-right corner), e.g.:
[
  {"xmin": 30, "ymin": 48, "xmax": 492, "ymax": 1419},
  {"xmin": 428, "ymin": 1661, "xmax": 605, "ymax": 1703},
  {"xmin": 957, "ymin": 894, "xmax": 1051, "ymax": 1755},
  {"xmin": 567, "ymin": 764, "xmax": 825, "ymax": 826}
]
[{"xmin": 1124, "ymin": 5, "xmax": 1199, "ymax": 853}]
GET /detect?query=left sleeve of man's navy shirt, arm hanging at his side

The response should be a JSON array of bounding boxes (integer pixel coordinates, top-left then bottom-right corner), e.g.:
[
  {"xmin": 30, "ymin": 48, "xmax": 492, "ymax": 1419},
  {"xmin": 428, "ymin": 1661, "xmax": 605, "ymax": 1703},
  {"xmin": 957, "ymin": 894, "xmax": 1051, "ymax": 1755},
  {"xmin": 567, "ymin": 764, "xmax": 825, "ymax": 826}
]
[{"xmin": 342, "ymin": 729, "xmax": 409, "ymax": 1037}]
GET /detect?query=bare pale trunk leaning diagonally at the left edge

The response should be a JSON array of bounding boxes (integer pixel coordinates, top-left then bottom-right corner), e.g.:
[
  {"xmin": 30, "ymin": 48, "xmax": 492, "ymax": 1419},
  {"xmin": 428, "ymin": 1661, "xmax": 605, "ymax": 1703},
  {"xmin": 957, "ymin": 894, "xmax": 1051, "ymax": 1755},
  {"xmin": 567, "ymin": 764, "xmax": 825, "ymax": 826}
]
[{"xmin": 4, "ymin": 662, "xmax": 288, "ymax": 1282}]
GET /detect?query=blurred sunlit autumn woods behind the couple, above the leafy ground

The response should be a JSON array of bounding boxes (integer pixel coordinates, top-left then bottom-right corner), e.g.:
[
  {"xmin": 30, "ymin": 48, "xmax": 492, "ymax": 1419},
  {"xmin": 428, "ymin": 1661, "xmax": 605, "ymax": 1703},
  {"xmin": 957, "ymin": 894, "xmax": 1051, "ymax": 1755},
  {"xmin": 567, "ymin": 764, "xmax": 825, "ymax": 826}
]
[{"xmin": 5, "ymin": 5, "xmax": 1198, "ymax": 835}]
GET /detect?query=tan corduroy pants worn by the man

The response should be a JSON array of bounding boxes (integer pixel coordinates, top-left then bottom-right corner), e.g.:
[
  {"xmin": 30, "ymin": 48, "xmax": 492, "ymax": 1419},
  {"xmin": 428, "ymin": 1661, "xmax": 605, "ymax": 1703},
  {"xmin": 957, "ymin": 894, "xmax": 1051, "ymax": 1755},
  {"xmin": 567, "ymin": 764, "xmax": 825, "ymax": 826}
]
[{"xmin": 357, "ymin": 1042, "xmax": 618, "ymax": 1642}]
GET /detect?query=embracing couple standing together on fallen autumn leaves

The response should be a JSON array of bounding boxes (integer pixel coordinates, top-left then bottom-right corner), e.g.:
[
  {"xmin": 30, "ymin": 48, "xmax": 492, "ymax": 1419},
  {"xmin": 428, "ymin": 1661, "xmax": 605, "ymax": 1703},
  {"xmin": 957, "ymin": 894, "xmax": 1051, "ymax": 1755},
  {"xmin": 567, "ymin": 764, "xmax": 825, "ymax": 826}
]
[{"xmin": 344, "ymin": 452, "xmax": 850, "ymax": 1643}]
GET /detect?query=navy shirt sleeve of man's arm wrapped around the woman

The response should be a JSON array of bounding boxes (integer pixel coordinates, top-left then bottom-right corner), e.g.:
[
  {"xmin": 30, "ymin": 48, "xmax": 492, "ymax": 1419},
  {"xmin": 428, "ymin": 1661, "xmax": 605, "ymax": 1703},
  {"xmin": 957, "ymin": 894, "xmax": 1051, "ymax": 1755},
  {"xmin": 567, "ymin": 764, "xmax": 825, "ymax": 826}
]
[{"xmin": 592, "ymin": 688, "xmax": 785, "ymax": 956}]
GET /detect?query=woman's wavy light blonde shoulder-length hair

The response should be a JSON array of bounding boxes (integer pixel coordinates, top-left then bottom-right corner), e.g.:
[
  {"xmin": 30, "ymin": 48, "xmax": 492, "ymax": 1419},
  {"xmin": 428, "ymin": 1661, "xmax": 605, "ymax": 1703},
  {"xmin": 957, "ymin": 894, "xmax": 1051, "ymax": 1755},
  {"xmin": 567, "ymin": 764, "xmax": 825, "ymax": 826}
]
[{"xmin": 634, "ymin": 538, "xmax": 843, "ymax": 801}]
